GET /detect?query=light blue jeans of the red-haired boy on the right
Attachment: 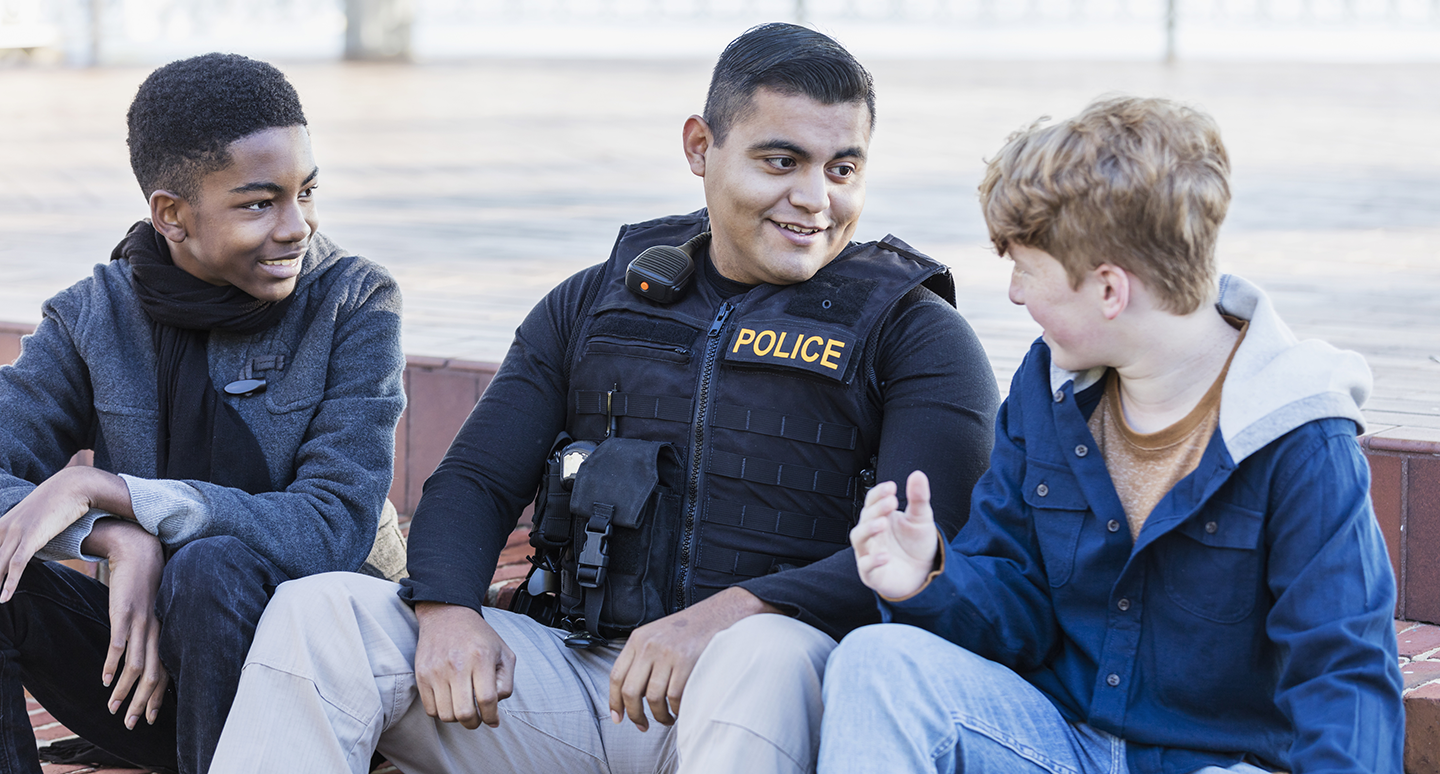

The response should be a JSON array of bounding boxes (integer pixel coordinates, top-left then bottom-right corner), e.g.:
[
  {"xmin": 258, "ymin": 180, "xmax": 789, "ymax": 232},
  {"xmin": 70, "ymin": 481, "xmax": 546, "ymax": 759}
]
[{"xmin": 819, "ymin": 624, "xmax": 1128, "ymax": 774}]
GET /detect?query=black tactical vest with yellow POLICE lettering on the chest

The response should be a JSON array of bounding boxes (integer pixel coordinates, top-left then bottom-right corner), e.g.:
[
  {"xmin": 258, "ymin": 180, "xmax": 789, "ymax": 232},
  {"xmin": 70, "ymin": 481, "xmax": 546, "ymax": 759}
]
[{"xmin": 550, "ymin": 210, "xmax": 955, "ymax": 626}]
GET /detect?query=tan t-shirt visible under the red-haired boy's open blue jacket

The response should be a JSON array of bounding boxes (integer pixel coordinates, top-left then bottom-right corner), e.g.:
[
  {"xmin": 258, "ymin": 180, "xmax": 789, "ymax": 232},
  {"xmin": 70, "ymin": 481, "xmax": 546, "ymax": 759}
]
[{"xmin": 1089, "ymin": 318, "xmax": 1248, "ymax": 539}]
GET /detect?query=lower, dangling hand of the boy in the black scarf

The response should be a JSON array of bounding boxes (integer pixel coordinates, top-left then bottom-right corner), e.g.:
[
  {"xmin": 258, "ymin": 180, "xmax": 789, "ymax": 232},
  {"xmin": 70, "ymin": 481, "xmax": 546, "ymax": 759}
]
[{"xmin": 85, "ymin": 518, "xmax": 170, "ymax": 728}]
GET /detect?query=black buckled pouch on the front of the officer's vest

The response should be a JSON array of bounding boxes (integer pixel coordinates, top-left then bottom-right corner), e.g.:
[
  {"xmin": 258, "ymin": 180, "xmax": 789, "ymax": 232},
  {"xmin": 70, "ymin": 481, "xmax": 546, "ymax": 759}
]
[{"xmin": 560, "ymin": 437, "xmax": 684, "ymax": 637}]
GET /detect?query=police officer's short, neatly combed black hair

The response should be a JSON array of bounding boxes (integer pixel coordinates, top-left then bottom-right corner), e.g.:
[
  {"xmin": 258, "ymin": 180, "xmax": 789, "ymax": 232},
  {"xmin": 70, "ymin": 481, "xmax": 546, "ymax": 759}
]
[{"xmin": 704, "ymin": 22, "xmax": 876, "ymax": 145}]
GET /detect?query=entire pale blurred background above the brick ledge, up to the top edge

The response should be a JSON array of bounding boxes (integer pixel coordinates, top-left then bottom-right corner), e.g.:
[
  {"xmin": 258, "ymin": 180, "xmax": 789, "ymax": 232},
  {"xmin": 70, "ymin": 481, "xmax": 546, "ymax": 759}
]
[{"xmin": 0, "ymin": 0, "xmax": 1440, "ymax": 420}]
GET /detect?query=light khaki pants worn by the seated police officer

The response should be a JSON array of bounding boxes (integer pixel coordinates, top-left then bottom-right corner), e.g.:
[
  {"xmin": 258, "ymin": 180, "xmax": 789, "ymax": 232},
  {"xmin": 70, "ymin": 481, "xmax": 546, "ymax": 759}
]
[{"xmin": 210, "ymin": 573, "xmax": 835, "ymax": 774}]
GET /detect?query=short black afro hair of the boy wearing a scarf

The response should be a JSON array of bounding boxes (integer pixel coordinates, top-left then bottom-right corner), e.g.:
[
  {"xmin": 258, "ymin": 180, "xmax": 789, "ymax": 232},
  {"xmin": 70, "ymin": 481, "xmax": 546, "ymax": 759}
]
[{"xmin": 127, "ymin": 53, "xmax": 305, "ymax": 199}]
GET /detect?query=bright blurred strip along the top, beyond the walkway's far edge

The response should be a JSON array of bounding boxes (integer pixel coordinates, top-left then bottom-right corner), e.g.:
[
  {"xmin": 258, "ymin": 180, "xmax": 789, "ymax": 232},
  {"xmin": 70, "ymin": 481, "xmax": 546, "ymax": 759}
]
[{"xmin": 0, "ymin": 0, "xmax": 1440, "ymax": 65}]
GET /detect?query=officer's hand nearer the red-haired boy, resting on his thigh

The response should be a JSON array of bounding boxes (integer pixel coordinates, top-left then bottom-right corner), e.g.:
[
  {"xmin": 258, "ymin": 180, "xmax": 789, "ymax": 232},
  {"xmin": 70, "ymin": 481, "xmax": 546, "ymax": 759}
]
[{"xmin": 611, "ymin": 587, "xmax": 779, "ymax": 731}]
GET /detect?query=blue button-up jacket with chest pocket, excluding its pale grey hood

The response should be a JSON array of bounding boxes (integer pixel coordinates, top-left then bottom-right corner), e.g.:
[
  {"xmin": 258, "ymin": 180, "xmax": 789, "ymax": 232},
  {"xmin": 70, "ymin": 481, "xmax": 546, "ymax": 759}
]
[{"xmin": 881, "ymin": 306, "xmax": 1404, "ymax": 774}]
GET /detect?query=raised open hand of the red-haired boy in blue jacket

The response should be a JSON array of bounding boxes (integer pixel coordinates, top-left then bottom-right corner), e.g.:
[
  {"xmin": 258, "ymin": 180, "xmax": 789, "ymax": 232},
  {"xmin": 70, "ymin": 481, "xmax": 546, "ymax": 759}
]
[{"xmin": 850, "ymin": 470, "xmax": 940, "ymax": 600}]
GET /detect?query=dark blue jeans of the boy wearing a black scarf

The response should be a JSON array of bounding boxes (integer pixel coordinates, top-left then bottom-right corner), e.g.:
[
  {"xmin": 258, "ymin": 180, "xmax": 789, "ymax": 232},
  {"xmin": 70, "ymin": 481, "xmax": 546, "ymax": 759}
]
[{"xmin": 0, "ymin": 537, "xmax": 289, "ymax": 774}]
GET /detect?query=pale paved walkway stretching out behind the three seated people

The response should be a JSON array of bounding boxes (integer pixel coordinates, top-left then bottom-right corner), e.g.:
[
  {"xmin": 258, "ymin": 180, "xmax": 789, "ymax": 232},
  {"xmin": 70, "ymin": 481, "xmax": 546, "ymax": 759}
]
[{"xmin": 0, "ymin": 58, "xmax": 1440, "ymax": 440}]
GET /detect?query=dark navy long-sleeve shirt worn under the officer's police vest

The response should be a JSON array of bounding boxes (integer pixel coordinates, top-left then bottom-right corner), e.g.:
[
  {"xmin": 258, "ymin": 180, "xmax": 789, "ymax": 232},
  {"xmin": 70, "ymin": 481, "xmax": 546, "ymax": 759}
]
[{"xmin": 400, "ymin": 244, "xmax": 999, "ymax": 639}]
